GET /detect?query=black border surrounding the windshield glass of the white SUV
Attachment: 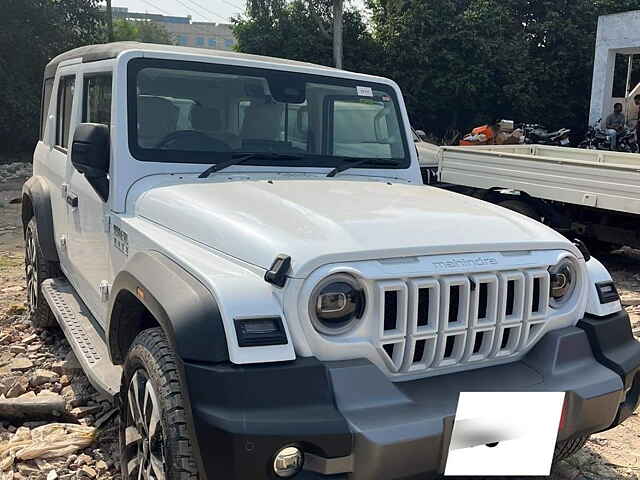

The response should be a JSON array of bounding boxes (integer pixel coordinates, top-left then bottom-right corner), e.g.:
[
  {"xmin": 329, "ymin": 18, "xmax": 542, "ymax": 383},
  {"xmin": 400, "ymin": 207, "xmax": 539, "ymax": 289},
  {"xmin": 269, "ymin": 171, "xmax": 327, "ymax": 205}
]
[{"xmin": 127, "ymin": 57, "xmax": 411, "ymax": 169}]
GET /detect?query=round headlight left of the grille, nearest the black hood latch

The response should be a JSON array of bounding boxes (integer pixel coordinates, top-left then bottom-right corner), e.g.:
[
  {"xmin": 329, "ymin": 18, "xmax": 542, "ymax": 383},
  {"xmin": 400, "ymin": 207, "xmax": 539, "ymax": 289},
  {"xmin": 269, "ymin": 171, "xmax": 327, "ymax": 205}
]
[{"xmin": 309, "ymin": 273, "xmax": 365, "ymax": 335}]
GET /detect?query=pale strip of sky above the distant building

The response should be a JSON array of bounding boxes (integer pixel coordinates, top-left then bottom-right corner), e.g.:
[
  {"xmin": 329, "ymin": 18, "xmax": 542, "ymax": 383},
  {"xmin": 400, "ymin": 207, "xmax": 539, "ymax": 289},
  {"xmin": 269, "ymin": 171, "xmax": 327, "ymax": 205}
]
[{"xmin": 111, "ymin": 0, "xmax": 245, "ymax": 23}]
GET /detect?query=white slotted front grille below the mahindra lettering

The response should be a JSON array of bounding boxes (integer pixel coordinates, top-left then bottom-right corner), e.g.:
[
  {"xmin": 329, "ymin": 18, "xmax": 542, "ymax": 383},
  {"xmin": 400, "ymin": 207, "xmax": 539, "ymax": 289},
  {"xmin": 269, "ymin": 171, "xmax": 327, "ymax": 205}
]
[{"xmin": 376, "ymin": 269, "xmax": 549, "ymax": 374}]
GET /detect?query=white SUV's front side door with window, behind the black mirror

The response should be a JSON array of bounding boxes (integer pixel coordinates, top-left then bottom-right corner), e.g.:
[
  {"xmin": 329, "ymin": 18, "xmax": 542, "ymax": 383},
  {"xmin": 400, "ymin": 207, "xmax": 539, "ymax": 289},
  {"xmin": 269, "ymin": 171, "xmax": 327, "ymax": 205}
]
[{"xmin": 67, "ymin": 71, "xmax": 113, "ymax": 324}]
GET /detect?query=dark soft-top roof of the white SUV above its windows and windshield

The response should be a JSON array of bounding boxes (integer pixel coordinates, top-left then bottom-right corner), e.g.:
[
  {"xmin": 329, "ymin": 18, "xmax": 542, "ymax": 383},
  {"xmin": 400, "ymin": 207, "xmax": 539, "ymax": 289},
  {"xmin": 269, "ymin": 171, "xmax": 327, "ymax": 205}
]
[{"xmin": 44, "ymin": 42, "xmax": 335, "ymax": 78}]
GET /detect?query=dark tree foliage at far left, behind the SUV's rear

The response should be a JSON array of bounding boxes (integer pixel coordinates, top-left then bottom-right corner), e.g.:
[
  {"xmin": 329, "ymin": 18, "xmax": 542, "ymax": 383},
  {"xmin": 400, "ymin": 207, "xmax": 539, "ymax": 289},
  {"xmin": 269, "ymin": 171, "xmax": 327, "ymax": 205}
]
[{"xmin": 0, "ymin": 0, "xmax": 101, "ymax": 152}]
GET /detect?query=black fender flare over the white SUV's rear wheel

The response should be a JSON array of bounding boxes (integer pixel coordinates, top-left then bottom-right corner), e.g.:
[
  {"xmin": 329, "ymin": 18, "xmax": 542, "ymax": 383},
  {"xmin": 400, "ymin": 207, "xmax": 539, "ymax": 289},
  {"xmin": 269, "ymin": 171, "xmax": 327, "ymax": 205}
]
[{"xmin": 22, "ymin": 176, "xmax": 60, "ymax": 263}]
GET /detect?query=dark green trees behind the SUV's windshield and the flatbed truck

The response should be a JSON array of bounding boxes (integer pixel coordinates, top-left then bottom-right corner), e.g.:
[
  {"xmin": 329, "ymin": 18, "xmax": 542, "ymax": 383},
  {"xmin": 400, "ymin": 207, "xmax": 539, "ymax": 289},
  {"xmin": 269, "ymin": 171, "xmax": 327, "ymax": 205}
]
[{"xmin": 235, "ymin": 0, "xmax": 640, "ymax": 136}]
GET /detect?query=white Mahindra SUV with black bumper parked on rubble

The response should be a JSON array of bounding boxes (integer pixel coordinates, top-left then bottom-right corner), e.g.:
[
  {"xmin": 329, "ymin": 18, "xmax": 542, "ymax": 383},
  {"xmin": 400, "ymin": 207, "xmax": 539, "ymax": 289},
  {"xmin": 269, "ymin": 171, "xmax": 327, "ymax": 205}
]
[{"xmin": 22, "ymin": 42, "xmax": 640, "ymax": 480}]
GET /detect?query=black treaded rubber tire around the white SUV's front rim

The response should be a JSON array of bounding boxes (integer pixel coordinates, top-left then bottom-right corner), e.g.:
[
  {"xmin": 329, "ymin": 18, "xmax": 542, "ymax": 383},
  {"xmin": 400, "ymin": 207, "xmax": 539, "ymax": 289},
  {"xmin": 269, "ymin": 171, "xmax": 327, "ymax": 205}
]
[{"xmin": 119, "ymin": 328, "xmax": 199, "ymax": 480}]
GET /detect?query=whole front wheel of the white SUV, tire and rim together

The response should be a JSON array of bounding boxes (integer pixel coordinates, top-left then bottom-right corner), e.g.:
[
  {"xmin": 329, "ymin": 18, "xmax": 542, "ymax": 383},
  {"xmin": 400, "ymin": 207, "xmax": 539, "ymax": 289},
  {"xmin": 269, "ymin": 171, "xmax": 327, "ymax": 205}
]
[{"xmin": 120, "ymin": 328, "xmax": 198, "ymax": 480}]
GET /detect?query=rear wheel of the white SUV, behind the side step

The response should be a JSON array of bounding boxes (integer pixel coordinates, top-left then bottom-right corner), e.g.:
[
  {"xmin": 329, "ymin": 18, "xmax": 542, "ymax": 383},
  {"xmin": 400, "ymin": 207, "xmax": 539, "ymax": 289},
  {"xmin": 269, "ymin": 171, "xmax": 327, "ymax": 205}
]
[{"xmin": 24, "ymin": 218, "xmax": 58, "ymax": 328}]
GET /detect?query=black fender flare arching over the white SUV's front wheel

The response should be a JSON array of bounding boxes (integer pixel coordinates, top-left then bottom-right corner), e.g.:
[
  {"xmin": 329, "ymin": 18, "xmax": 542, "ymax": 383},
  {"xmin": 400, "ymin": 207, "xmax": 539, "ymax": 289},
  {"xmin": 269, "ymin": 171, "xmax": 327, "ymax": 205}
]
[{"xmin": 107, "ymin": 251, "xmax": 229, "ymax": 363}]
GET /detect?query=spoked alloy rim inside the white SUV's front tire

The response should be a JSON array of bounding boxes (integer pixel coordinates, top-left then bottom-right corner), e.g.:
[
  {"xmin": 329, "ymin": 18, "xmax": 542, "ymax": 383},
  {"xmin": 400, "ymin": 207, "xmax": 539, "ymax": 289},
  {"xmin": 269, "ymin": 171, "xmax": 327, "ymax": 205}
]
[{"xmin": 124, "ymin": 369, "xmax": 166, "ymax": 480}]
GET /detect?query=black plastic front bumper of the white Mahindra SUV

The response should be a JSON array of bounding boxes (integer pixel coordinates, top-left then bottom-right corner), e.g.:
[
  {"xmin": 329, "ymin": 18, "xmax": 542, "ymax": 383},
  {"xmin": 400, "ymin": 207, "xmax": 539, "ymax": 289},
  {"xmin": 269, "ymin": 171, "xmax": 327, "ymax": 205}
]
[{"xmin": 185, "ymin": 312, "xmax": 640, "ymax": 480}]
